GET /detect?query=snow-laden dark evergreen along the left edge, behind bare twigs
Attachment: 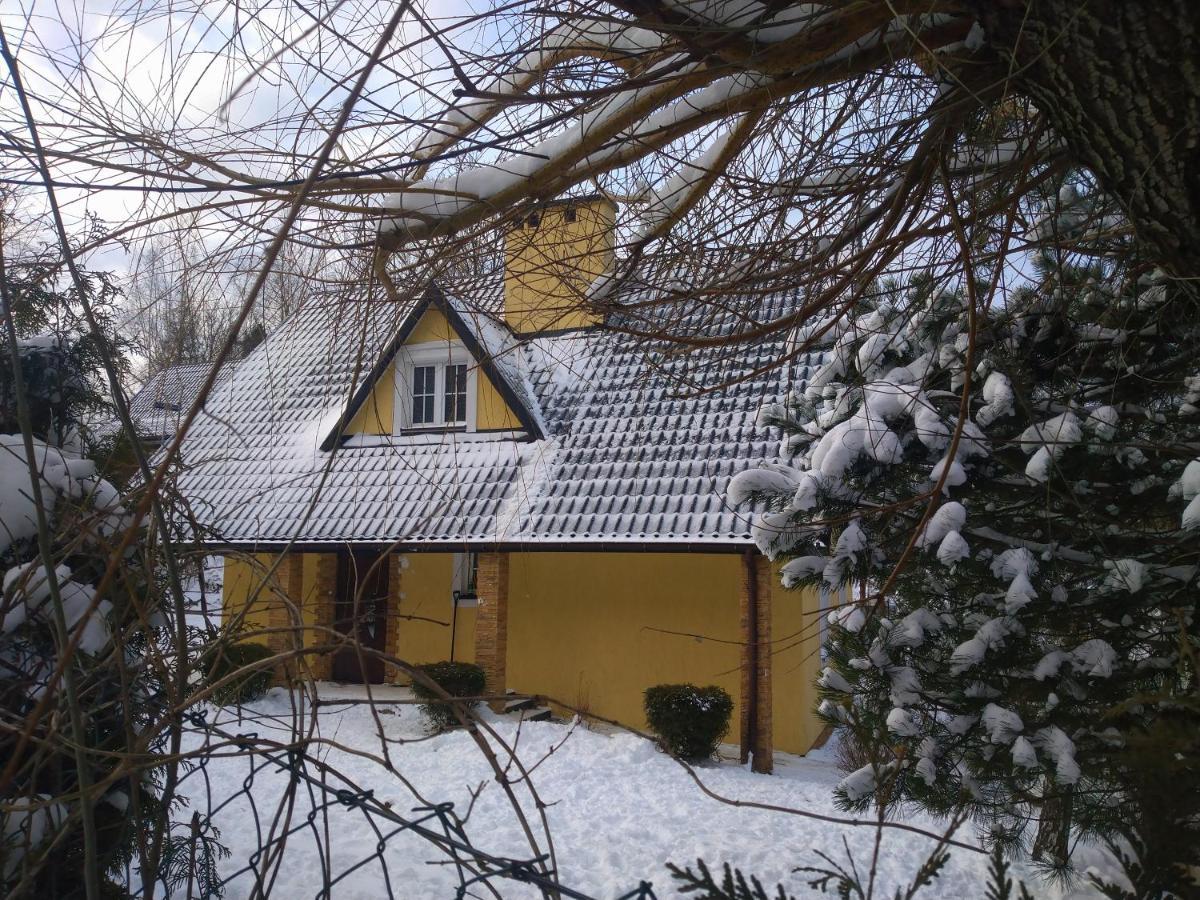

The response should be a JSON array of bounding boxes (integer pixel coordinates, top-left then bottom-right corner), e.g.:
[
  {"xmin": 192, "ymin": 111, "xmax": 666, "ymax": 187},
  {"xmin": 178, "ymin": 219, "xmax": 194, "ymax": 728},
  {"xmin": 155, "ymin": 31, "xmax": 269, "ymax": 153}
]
[{"xmin": 0, "ymin": 328, "xmax": 223, "ymax": 898}]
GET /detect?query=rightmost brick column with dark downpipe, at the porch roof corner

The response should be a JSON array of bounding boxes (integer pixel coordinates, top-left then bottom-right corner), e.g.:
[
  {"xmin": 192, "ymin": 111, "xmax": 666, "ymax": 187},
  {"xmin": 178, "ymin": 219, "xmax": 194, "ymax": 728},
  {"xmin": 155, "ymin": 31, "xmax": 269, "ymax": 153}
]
[{"xmin": 739, "ymin": 552, "xmax": 773, "ymax": 773}]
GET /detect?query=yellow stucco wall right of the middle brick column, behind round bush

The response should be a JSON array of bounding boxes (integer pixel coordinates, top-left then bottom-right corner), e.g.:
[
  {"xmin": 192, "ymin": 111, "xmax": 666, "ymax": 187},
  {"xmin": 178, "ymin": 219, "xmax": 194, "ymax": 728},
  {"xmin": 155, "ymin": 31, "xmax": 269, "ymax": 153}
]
[{"xmin": 508, "ymin": 553, "xmax": 820, "ymax": 752}]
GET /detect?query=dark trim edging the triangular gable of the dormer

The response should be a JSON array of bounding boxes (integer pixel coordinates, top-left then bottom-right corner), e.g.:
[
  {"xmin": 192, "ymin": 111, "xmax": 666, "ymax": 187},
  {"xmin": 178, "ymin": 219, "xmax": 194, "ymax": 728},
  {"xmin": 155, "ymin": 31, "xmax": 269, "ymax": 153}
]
[{"xmin": 320, "ymin": 282, "xmax": 546, "ymax": 451}]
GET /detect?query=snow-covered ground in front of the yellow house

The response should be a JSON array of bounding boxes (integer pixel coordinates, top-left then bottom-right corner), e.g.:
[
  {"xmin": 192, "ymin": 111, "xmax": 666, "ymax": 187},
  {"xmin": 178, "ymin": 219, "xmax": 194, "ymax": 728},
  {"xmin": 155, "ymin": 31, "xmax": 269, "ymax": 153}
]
[{"xmin": 174, "ymin": 684, "xmax": 1096, "ymax": 900}]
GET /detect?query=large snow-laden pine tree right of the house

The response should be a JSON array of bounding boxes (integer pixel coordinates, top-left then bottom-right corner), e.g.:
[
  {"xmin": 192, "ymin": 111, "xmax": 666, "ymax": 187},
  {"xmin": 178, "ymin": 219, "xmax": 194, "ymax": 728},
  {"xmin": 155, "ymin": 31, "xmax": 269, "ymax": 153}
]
[{"xmin": 730, "ymin": 186, "xmax": 1200, "ymax": 896}]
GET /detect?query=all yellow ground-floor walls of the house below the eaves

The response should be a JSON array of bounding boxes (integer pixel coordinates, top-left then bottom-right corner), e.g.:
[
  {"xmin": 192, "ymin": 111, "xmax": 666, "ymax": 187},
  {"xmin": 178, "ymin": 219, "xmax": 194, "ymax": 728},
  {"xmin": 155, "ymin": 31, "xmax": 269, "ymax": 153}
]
[{"xmin": 223, "ymin": 552, "xmax": 821, "ymax": 754}]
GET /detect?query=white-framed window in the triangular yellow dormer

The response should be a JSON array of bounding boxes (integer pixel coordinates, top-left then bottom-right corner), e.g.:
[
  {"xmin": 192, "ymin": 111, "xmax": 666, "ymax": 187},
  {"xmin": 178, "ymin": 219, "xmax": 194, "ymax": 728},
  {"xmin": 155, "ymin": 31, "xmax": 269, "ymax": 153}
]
[{"xmin": 396, "ymin": 343, "xmax": 475, "ymax": 431}]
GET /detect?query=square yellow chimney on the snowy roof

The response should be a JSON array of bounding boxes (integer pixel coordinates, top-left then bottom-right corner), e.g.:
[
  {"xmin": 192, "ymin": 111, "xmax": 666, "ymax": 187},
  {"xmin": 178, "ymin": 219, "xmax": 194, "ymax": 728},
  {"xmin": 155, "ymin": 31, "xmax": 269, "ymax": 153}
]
[{"xmin": 504, "ymin": 197, "xmax": 617, "ymax": 335}]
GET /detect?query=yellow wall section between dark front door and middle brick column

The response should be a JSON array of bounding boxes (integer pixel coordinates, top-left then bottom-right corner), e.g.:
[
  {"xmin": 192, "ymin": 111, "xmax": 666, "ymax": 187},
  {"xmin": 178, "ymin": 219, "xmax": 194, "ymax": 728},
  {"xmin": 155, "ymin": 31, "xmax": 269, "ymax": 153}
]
[{"xmin": 396, "ymin": 553, "xmax": 475, "ymax": 664}]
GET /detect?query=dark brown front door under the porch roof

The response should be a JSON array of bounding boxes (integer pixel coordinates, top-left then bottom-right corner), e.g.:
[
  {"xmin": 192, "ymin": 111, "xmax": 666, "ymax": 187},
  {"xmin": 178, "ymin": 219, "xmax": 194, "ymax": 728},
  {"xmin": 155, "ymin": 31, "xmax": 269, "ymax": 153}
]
[{"xmin": 332, "ymin": 552, "xmax": 389, "ymax": 684}]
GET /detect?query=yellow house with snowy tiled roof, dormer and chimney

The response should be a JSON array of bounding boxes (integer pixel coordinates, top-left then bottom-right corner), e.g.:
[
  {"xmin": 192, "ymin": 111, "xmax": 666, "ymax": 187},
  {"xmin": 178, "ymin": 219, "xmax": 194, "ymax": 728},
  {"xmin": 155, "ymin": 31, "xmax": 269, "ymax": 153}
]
[{"xmin": 180, "ymin": 198, "xmax": 821, "ymax": 770}]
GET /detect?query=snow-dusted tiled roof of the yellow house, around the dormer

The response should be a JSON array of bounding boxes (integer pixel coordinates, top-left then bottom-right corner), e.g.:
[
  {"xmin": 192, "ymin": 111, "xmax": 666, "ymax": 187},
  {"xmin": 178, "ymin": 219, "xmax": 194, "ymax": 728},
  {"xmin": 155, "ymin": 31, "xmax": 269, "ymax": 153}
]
[{"xmin": 180, "ymin": 267, "xmax": 817, "ymax": 547}]
